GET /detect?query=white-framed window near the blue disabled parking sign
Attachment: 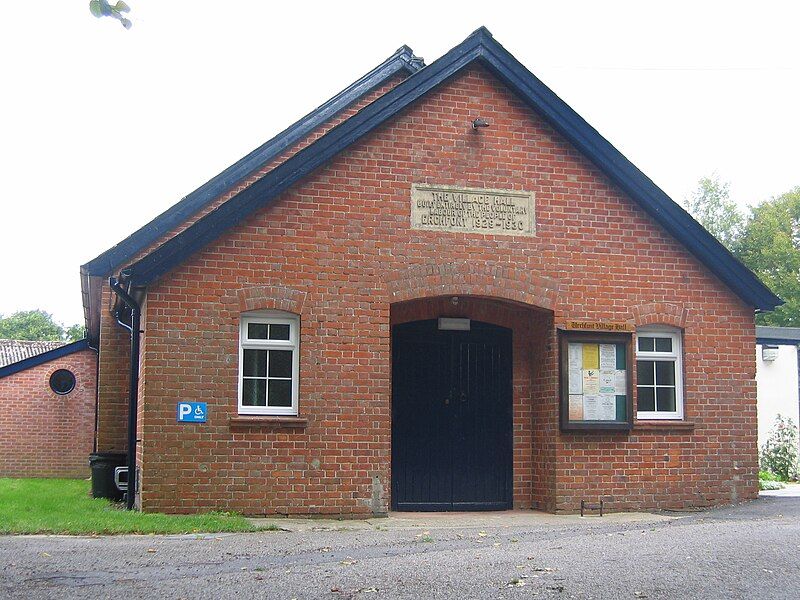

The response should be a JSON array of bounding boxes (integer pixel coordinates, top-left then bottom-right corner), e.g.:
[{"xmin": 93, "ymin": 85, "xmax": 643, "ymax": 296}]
[{"xmin": 239, "ymin": 311, "xmax": 300, "ymax": 415}]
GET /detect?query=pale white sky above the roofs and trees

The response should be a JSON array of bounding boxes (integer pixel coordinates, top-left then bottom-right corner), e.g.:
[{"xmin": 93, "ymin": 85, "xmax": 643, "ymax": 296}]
[{"xmin": 0, "ymin": 0, "xmax": 800, "ymax": 324}]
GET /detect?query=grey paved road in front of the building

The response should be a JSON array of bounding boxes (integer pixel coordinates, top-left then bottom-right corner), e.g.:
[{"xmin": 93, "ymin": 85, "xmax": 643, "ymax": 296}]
[{"xmin": 0, "ymin": 497, "xmax": 800, "ymax": 600}]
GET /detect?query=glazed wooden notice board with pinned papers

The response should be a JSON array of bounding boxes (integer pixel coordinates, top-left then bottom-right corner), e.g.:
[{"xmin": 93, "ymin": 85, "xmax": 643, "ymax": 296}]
[{"xmin": 560, "ymin": 331, "xmax": 633, "ymax": 431}]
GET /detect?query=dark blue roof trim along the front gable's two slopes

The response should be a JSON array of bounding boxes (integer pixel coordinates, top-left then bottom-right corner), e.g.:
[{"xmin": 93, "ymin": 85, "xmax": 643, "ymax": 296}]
[{"xmin": 127, "ymin": 27, "xmax": 783, "ymax": 310}]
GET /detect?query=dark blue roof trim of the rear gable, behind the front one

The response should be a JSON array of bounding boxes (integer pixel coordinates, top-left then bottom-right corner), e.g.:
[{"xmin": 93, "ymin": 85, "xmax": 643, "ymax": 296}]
[{"xmin": 81, "ymin": 46, "xmax": 425, "ymax": 276}]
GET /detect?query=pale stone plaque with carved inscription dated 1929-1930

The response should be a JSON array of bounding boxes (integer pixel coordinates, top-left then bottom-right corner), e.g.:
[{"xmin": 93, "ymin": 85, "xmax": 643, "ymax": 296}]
[{"xmin": 411, "ymin": 184, "xmax": 536, "ymax": 236}]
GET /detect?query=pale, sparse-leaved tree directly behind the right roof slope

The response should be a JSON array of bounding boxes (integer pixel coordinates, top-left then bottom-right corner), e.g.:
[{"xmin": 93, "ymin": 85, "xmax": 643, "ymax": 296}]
[{"xmin": 684, "ymin": 175, "xmax": 744, "ymax": 252}]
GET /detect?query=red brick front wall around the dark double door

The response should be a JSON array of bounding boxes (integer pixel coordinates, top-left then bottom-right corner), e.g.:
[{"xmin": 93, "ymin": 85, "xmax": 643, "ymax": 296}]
[{"xmin": 111, "ymin": 67, "xmax": 756, "ymax": 515}]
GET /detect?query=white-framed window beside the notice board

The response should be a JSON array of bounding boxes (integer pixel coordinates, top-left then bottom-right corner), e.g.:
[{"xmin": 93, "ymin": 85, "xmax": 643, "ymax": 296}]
[{"xmin": 636, "ymin": 327, "xmax": 683, "ymax": 419}]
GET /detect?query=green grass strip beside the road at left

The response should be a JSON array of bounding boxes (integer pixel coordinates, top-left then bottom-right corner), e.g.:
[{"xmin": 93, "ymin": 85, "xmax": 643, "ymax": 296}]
[{"xmin": 0, "ymin": 478, "xmax": 259, "ymax": 535}]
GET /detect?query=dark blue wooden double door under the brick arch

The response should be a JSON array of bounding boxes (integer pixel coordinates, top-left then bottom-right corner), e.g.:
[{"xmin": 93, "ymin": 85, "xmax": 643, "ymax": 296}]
[{"xmin": 392, "ymin": 319, "xmax": 513, "ymax": 511}]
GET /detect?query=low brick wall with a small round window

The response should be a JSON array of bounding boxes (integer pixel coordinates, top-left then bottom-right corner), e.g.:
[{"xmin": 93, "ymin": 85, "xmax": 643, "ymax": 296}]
[{"xmin": 0, "ymin": 350, "xmax": 97, "ymax": 477}]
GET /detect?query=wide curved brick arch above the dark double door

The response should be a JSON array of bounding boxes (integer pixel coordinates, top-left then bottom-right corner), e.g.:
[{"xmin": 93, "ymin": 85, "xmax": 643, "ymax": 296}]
[{"xmin": 385, "ymin": 261, "xmax": 559, "ymax": 310}]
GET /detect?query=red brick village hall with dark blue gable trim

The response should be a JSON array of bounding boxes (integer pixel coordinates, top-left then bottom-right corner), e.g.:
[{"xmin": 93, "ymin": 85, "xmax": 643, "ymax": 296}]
[{"xmin": 82, "ymin": 29, "xmax": 780, "ymax": 516}]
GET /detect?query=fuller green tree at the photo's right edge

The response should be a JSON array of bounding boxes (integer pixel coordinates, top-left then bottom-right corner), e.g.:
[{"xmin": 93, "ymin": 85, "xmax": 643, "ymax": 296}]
[{"xmin": 737, "ymin": 187, "xmax": 800, "ymax": 327}]
